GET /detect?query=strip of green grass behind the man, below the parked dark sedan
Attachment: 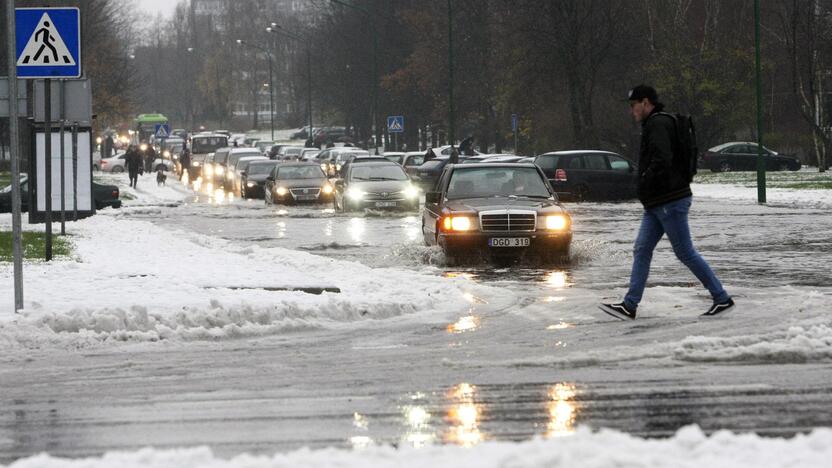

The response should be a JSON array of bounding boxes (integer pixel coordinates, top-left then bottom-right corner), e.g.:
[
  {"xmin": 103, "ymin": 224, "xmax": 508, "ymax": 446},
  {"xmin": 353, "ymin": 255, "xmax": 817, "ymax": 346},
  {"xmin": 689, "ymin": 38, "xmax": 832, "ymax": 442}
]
[{"xmin": 694, "ymin": 169, "xmax": 832, "ymax": 190}]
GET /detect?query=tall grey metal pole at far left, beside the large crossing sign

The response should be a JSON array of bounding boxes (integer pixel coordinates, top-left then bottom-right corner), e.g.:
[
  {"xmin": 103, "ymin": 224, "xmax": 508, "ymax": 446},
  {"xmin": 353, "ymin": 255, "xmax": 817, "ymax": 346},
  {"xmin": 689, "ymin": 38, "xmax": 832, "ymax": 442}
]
[{"xmin": 6, "ymin": 0, "xmax": 23, "ymax": 312}]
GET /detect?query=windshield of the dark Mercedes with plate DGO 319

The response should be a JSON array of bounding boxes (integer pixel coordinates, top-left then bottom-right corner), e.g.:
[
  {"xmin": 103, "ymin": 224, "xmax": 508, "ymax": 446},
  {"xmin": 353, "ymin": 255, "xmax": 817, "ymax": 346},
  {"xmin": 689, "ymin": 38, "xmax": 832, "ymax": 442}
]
[{"xmin": 448, "ymin": 167, "xmax": 551, "ymax": 200}]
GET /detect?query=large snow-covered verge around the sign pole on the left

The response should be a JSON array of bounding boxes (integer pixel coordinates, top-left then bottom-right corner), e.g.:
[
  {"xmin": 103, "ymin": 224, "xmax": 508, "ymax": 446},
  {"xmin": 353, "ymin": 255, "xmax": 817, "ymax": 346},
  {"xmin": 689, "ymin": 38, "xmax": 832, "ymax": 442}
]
[{"xmin": 0, "ymin": 177, "xmax": 500, "ymax": 348}]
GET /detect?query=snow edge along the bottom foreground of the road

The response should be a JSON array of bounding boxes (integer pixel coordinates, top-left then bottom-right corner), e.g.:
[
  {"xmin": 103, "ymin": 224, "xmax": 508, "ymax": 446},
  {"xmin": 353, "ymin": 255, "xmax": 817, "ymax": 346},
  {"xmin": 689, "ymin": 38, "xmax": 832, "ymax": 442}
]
[{"xmin": 9, "ymin": 426, "xmax": 832, "ymax": 468}]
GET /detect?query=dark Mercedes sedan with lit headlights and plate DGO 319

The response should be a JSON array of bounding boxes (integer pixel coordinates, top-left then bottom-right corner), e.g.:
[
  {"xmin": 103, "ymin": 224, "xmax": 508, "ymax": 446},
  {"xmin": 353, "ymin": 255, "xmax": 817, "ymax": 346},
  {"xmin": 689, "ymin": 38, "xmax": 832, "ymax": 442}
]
[{"xmin": 422, "ymin": 163, "xmax": 572, "ymax": 265}]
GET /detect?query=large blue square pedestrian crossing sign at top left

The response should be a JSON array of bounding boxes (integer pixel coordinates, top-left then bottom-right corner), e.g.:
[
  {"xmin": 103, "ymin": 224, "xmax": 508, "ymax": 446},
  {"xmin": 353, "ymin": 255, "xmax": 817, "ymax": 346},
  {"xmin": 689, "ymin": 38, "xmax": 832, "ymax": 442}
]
[{"xmin": 15, "ymin": 8, "xmax": 81, "ymax": 78}]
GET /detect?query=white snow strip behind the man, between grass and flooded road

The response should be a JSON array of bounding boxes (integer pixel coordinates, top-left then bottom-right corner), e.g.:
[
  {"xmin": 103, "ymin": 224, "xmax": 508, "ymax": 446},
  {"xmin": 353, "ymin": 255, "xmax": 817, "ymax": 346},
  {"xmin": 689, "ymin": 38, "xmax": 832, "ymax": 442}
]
[{"xmin": 691, "ymin": 184, "xmax": 832, "ymax": 208}]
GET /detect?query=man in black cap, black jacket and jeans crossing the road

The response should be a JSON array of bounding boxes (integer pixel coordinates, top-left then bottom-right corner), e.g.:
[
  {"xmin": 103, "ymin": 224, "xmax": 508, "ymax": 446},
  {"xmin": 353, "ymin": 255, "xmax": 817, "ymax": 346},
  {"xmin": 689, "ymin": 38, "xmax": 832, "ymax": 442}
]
[{"xmin": 600, "ymin": 85, "xmax": 734, "ymax": 320}]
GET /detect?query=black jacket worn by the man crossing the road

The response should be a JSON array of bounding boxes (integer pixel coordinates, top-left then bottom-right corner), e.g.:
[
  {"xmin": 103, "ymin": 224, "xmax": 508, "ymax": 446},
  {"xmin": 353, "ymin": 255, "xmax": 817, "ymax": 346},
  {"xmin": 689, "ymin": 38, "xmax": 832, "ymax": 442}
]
[{"xmin": 638, "ymin": 107, "xmax": 691, "ymax": 208}]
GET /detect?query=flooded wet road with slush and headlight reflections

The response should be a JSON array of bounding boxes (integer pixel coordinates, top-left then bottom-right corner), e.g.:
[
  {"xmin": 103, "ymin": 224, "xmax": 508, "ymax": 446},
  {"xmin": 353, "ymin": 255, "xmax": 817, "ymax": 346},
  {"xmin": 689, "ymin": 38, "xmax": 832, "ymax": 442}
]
[{"xmin": 0, "ymin": 178, "xmax": 832, "ymax": 462}]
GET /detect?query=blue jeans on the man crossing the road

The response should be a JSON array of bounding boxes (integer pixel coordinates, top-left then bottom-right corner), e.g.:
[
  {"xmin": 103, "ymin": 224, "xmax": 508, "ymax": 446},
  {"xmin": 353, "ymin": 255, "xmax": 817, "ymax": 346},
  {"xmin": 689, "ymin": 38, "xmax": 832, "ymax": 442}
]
[{"xmin": 624, "ymin": 197, "xmax": 730, "ymax": 310}]
